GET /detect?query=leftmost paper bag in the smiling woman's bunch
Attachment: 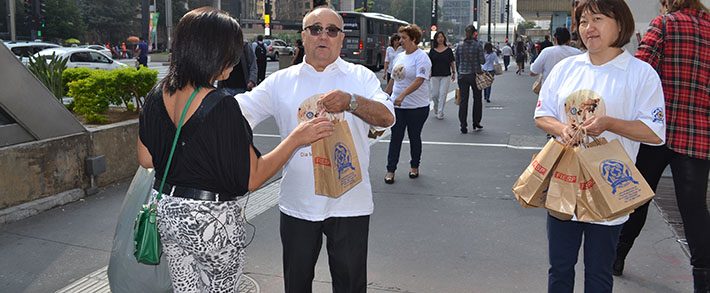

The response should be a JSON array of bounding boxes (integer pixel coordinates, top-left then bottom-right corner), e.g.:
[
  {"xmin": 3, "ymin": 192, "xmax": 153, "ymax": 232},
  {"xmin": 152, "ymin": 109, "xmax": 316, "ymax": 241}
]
[{"xmin": 513, "ymin": 139, "xmax": 564, "ymax": 208}]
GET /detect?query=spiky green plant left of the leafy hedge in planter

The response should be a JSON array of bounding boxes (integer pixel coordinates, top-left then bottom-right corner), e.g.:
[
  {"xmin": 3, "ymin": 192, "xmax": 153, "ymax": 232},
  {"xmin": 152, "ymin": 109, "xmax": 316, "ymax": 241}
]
[{"xmin": 27, "ymin": 54, "xmax": 67, "ymax": 102}]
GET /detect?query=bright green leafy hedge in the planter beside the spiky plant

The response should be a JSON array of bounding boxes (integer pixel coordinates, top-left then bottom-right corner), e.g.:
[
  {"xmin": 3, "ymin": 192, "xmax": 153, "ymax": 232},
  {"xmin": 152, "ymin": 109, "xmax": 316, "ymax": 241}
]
[{"xmin": 65, "ymin": 67, "xmax": 158, "ymax": 123}]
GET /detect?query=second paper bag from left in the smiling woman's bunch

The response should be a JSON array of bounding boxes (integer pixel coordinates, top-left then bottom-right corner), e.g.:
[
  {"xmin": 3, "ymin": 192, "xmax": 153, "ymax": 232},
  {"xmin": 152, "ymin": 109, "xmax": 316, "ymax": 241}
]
[{"xmin": 545, "ymin": 147, "xmax": 581, "ymax": 221}]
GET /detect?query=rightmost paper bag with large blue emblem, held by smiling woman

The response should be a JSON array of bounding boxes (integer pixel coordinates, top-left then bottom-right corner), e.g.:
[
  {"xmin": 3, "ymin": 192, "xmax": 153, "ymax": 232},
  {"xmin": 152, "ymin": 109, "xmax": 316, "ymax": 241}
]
[{"xmin": 577, "ymin": 139, "xmax": 655, "ymax": 219}]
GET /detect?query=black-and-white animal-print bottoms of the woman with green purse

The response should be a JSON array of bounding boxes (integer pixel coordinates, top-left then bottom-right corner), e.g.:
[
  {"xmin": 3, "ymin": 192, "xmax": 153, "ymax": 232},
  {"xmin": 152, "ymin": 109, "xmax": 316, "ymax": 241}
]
[{"xmin": 153, "ymin": 190, "xmax": 246, "ymax": 292}]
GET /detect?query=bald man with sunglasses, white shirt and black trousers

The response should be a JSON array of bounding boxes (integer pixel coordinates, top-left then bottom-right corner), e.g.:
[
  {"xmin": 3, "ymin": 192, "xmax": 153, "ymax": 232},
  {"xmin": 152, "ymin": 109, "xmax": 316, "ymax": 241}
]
[{"xmin": 236, "ymin": 7, "xmax": 395, "ymax": 293}]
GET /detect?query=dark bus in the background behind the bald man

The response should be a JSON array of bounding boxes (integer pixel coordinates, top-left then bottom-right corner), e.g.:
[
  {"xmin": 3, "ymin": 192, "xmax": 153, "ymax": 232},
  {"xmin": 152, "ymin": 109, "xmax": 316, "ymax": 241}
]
[{"xmin": 339, "ymin": 11, "xmax": 409, "ymax": 71}]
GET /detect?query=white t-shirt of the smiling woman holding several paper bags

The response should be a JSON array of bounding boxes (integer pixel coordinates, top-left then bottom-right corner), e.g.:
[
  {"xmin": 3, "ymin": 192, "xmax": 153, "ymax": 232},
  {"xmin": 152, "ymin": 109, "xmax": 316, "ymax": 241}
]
[{"xmin": 535, "ymin": 49, "xmax": 666, "ymax": 225}]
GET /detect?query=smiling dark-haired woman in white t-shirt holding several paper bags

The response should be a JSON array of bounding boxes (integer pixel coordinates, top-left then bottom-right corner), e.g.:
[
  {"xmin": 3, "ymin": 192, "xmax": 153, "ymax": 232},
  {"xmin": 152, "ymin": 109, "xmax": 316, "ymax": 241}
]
[{"xmin": 535, "ymin": 0, "xmax": 665, "ymax": 292}]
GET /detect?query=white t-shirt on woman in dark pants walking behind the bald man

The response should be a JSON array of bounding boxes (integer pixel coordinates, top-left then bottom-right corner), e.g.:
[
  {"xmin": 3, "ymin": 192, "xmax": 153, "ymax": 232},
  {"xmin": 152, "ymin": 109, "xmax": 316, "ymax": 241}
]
[{"xmin": 391, "ymin": 49, "xmax": 431, "ymax": 109}]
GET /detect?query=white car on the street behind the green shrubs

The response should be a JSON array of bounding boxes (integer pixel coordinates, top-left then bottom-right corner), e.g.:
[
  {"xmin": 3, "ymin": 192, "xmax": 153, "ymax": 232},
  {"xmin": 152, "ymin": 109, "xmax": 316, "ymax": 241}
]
[{"xmin": 35, "ymin": 47, "xmax": 128, "ymax": 69}]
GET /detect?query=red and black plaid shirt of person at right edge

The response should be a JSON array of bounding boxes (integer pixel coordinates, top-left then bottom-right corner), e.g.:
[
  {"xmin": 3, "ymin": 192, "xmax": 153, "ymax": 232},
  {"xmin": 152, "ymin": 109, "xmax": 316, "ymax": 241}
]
[{"xmin": 636, "ymin": 9, "xmax": 710, "ymax": 160}]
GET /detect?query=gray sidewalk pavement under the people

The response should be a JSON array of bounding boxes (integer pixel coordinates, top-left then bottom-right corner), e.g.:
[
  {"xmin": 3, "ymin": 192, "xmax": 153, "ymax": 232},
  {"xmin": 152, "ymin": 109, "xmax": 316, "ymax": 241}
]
[{"xmin": 0, "ymin": 64, "xmax": 692, "ymax": 293}]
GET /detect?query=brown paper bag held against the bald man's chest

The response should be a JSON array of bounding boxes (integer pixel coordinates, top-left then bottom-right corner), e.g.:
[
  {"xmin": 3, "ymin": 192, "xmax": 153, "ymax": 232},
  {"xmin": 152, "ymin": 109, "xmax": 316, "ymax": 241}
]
[{"xmin": 311, "ymin": 120, "xmax": 362, "ymax": 198}]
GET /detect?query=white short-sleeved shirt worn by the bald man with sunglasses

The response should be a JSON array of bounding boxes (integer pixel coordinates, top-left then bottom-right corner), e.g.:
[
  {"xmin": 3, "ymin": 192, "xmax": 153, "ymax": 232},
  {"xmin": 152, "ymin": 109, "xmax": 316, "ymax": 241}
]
[{"xmin": 236, "ymin": 56, "xmax": 394, "ymax": 221}]
